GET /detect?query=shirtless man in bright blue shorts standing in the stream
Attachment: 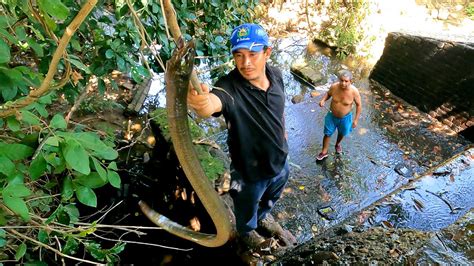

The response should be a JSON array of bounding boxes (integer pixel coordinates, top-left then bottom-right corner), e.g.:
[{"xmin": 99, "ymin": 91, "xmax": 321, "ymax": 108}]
[{"xmin": 316, "ymin": 70, "xmax": 362, "ymax": 161}]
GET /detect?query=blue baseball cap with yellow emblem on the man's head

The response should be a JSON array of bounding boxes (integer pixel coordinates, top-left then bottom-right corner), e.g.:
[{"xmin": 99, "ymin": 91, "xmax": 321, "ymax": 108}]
[{"xmin": 230, "ymin": 23, "xmax": 269, "ymax": 53}]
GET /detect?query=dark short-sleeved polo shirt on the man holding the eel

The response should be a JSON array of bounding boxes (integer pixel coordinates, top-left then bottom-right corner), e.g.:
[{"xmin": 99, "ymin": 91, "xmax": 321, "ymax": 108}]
[{"xmin": 212, "ymin": 64, "xmax": 288, "ymax": 181}]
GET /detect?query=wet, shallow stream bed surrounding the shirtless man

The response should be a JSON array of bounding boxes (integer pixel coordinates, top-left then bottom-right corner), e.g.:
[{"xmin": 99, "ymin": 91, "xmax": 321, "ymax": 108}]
[{"xmin": 262, "ymin": 35, "xmax": 474, "ymax": 264}]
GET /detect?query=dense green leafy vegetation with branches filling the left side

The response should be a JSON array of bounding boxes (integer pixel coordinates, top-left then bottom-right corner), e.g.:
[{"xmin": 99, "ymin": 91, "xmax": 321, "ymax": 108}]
[{"xmin": 0, "ymin": 0, "xmax": 256, "ymax": 263}]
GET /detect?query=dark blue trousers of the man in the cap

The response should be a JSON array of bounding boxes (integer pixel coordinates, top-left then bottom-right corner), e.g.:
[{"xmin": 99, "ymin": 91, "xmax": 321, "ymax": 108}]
[{"xmin": 230, "ymin": 161, "xmax": 290, "ymax": 235}]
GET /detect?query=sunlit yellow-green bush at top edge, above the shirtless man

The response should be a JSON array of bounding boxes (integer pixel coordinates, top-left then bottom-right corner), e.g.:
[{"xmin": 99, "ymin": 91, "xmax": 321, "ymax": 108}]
[{"xmin": 316, "ymin": 1, "xmax": 369, "ymax": 58}]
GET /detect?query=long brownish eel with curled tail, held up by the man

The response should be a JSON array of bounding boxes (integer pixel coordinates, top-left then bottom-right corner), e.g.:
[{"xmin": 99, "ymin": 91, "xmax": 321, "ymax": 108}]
[{"xmin": 138, "ymin": 39, "xmax": 232, "ymax": 247}]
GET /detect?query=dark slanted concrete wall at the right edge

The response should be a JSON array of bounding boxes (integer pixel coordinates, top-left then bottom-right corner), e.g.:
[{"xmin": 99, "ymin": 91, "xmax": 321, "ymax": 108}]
[{"xmin": 370, "ymin": 33, "xmax": 474, "ymax": 141}]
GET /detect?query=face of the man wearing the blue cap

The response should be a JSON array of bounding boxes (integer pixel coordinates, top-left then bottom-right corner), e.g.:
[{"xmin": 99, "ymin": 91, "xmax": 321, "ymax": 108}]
[{"xmin": 233, "ymin": 47, "xmax": 271, "ymax": 81}]
